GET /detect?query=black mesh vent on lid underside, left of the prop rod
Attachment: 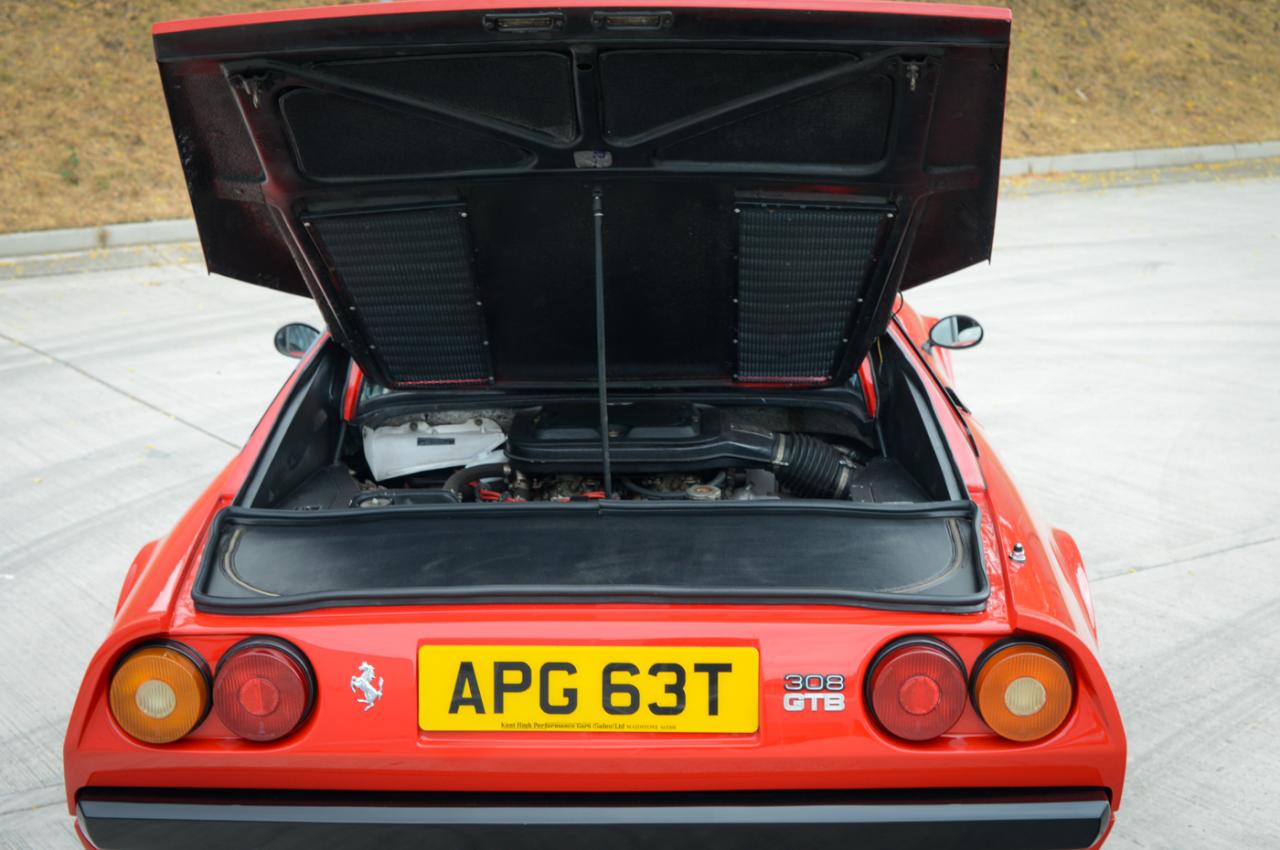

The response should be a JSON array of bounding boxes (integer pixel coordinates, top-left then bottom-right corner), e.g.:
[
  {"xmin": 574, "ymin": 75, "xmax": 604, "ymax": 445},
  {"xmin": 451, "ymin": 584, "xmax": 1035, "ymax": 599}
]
[{"xmin": 308, "ymin": 206, "xmax": 493, "ymax": 387}]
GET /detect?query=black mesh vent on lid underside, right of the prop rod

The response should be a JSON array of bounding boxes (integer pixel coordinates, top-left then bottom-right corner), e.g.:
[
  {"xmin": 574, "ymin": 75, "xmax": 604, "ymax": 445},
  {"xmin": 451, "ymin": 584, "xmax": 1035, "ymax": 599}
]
[{"xmin": 737, "ymin": 206, "xmax": 884, "ymax": 383}]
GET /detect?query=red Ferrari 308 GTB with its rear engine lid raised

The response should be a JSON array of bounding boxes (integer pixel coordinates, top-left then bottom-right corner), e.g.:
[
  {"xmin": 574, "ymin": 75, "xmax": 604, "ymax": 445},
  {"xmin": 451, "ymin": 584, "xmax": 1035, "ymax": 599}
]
[{"xmin": 65, "ymin": 0, "xmax": 1125, "ymax": 850}]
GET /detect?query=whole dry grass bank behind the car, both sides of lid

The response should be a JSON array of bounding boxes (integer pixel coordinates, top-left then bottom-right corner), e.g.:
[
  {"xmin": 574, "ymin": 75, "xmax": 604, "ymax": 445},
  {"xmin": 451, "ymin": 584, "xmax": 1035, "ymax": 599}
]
[{"xmin": 0, "ymin": 0, "xmax": 1280, "ymax": 232}]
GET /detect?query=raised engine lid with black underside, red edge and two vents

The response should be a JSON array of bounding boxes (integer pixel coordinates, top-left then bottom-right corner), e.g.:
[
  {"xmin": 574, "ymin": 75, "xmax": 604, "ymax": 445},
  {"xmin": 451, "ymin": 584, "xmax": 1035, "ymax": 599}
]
[{"xmin": 154, "ymin": 0, "xmax": 1009, "ymax": 389}]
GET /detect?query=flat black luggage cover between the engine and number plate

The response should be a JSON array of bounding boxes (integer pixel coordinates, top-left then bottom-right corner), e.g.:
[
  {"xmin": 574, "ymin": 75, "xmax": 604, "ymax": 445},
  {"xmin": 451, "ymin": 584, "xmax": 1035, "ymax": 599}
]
[{"xmin": 192, "ymin": 501, "xmax": 989, "ymax": 614}]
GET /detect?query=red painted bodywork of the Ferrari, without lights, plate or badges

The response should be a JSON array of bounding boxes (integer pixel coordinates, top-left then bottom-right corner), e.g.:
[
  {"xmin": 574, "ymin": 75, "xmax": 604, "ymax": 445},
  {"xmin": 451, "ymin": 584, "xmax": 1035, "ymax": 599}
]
[{"xmin": 64, "ymin": 0, "xmax": 1125, "ymax": 846}]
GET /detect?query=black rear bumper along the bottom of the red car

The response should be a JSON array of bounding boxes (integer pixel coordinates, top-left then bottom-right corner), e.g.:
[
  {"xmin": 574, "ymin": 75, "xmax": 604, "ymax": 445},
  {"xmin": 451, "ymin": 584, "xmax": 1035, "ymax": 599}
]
[{"xmin": 76, "ymin": 789, "xmax": 1111, "ymax": 850}]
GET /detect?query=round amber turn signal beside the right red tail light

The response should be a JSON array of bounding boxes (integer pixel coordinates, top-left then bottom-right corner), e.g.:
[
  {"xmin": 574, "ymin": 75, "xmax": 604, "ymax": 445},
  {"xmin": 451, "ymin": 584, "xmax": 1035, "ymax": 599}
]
[{"xmin": 973, "ymin": 643, "xmax": 1073, "ymax": 741}]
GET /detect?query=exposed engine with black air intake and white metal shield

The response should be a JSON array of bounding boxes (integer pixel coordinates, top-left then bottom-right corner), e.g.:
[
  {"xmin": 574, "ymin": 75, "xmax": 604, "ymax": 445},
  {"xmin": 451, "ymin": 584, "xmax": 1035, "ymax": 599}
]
[{"xmin": 276, "ymin": 401, "xmax": 924, "ymax": 509}]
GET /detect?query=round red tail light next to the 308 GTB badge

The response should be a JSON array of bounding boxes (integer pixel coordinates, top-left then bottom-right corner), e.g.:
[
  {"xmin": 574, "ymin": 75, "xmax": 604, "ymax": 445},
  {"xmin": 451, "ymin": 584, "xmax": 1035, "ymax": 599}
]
[{"xmin": 867, "ymin": 638, "xmax": 969, "ymax": 741}]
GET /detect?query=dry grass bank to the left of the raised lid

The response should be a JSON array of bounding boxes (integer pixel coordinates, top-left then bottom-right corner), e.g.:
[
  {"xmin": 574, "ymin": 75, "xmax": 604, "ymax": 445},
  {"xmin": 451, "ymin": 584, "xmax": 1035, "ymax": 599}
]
[{"xmin": 0, "ymin": 0, "xmax": 301, "ymax": 232}]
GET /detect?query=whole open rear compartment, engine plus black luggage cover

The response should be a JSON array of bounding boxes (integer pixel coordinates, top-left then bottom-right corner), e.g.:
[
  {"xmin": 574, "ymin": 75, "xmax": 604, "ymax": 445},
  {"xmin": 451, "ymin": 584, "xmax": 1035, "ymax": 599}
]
[{"xmin": 215, "ymin": 346, "xmax": 987, "ymax": 613}]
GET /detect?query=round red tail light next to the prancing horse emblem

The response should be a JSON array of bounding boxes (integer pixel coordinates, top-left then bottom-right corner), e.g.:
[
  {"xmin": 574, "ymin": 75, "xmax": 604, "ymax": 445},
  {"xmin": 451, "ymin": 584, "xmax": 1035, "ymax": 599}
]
[{"xmin": 214, "ymin": 638, "xmax": 315, "ymax": 741}]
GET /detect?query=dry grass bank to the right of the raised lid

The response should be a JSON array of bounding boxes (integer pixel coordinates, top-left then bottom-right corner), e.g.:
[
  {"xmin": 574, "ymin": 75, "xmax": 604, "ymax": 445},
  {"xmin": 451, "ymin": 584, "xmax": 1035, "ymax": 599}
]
[{"xmin": 1005, "ymin": 0, "xmax": 1280, "ymax": 156}]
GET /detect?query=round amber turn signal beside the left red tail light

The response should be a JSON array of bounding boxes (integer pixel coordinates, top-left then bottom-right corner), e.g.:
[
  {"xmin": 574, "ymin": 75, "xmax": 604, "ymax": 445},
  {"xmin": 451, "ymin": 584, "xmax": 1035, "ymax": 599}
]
[{"xmin": 109, "ymin": 644, "xmax": 209, "ymax": 744}]
